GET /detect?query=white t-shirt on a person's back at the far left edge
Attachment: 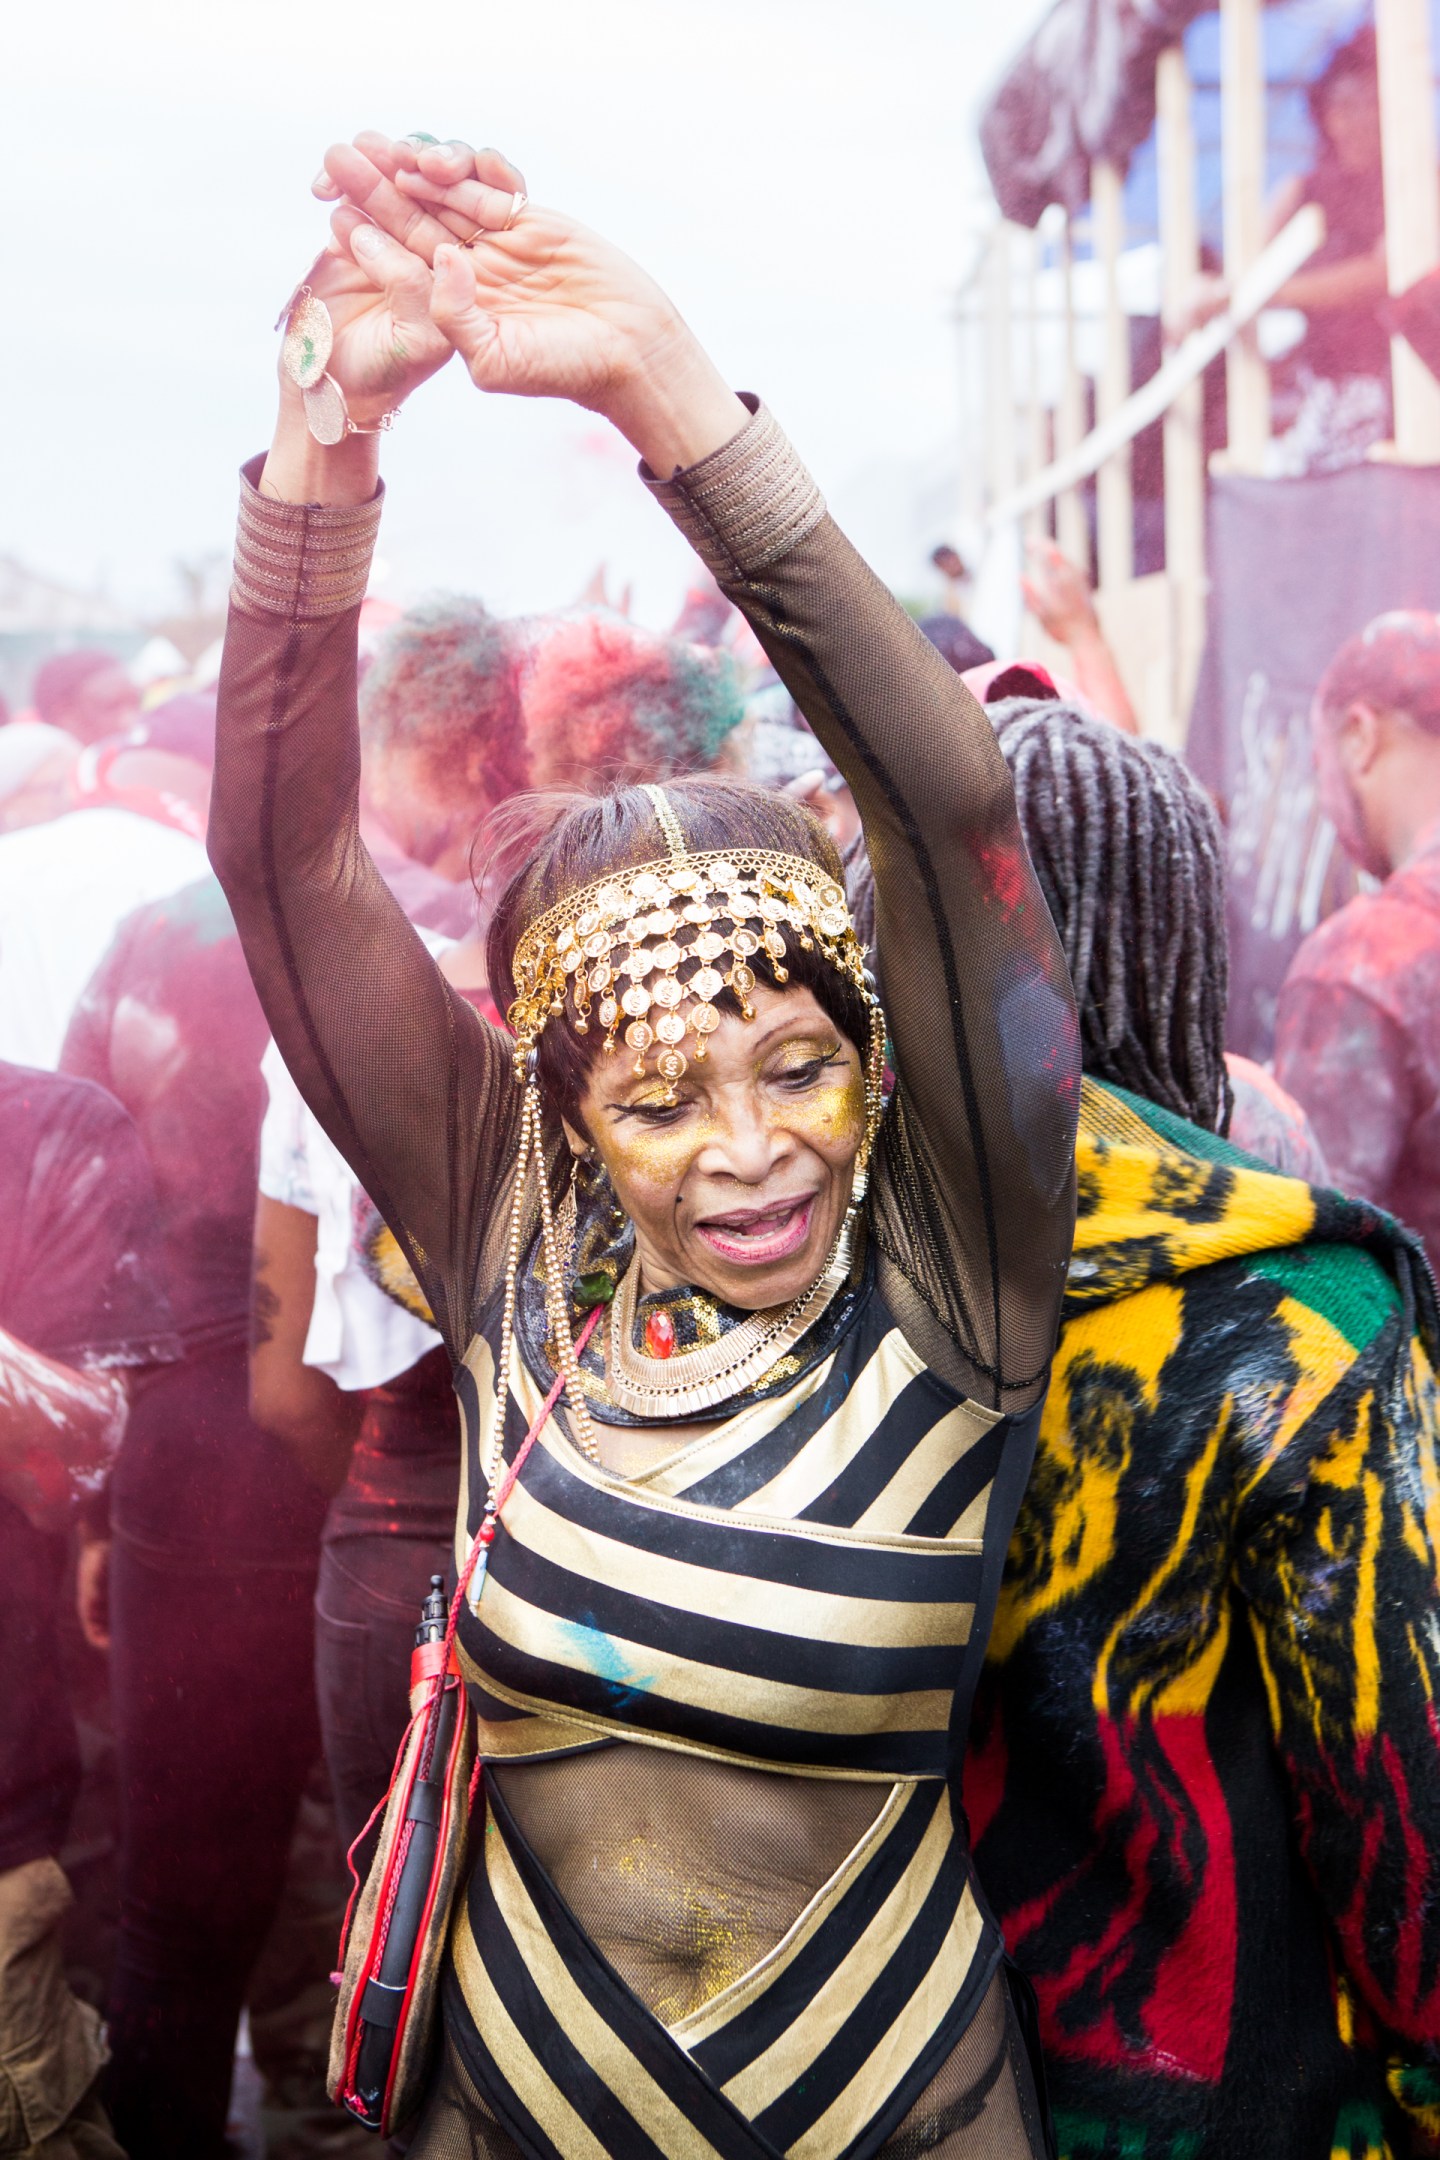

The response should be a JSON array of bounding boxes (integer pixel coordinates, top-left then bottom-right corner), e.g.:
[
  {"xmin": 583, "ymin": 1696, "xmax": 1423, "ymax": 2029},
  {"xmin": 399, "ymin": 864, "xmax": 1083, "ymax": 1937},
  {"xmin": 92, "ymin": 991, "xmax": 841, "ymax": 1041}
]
[{"xmin": 0, "ymin": 810, "xmax": 209, "ymax": 1071}]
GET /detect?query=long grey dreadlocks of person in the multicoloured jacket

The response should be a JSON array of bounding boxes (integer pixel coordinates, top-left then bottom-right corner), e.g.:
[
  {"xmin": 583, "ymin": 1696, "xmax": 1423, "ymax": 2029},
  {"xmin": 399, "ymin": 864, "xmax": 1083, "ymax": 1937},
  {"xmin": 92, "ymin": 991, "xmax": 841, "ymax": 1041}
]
[{"xmin": 989, "ymin": 698, "xmax": 1233, "ymax": 1132}]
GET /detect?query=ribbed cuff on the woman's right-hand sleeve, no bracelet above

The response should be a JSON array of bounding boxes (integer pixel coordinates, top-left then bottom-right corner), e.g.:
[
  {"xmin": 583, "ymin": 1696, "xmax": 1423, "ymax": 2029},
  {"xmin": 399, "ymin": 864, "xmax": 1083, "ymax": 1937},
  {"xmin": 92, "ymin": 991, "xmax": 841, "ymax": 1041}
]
[{"xmin": 639, "ymin": 391, "xmax": 825, "ymax": 583}]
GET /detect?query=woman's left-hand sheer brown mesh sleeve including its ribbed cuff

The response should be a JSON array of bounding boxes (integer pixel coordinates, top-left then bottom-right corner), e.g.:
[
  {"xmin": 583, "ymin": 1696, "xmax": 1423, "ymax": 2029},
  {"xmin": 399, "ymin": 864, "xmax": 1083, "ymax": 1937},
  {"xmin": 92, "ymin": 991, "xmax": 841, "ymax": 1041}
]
[{"xmin": 209, "ymin": 460, "xmax": 518, "ymax": 1354}]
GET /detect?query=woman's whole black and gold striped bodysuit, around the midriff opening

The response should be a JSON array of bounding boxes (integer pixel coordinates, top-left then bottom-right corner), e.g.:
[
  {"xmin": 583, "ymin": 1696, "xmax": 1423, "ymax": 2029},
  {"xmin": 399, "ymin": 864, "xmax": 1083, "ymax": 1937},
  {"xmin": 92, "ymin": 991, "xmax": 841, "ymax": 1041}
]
[{"xmin": 427, "ymin": 1290, "xmax": 1049, "ymax": 2160}]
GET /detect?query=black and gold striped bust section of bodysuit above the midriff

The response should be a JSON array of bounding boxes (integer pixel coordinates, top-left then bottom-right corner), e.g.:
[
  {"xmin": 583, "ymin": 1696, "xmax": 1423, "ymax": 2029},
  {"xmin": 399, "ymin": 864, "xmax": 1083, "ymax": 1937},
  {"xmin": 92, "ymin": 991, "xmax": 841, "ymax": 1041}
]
[{"xmin": 460, "ymin": 1300, "xmax": 1004, "ymax": 1778}]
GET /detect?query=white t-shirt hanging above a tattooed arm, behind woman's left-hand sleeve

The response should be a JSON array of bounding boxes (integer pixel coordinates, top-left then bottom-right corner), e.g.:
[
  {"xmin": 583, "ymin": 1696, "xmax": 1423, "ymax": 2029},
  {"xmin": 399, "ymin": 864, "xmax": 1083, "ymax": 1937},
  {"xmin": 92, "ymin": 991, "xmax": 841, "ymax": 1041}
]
[{"xmin": 259, "ymin": 1036, "xmax": 449, "ymax": 1389}]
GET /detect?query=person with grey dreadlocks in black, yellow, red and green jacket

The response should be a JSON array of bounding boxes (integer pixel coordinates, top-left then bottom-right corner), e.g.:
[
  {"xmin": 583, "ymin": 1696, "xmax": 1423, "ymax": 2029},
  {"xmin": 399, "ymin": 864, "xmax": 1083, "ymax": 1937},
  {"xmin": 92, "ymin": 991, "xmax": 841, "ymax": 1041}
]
[{"xmin": 949, "ymin": 700, "xmax": 1440, "ymax": 2160}]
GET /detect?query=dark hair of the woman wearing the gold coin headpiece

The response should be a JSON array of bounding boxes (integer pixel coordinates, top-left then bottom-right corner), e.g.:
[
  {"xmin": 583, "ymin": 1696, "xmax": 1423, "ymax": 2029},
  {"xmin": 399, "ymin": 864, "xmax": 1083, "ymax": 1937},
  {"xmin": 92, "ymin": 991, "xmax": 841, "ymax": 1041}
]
[{"xmin": 479, "ymin": 773, "xmax": 868, "ymax": 1130}]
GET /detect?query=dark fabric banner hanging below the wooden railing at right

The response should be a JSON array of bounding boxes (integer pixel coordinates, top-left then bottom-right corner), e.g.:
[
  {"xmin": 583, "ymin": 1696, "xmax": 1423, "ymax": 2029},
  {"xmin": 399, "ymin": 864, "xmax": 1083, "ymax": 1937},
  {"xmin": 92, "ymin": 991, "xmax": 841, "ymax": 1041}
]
[{"xmin": 1187, "ymin": 464, "xmax": 1440, "ymax": 1061}]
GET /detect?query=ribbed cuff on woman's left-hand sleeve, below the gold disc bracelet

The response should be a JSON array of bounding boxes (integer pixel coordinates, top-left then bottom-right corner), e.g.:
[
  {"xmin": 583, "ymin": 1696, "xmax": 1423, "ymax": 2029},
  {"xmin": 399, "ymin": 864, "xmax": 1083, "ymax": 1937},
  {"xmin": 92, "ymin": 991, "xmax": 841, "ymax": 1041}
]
[{"xmin": 231, "ymin": 458, "xmax": 384, "ymax": 622}]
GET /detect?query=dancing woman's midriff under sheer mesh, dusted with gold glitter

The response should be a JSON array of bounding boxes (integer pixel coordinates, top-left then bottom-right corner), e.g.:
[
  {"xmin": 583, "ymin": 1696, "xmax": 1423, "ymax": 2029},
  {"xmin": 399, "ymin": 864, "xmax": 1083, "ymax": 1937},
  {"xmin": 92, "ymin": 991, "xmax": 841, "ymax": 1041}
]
[{"xmin": 490, "ymin": 1741, "xmax": 889, "ymax": 2024}]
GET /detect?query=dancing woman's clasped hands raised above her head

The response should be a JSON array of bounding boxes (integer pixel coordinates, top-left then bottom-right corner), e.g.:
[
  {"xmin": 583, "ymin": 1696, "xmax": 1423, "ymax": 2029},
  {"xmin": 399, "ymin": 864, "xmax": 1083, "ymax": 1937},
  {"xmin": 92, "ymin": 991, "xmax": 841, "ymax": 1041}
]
[{"xmin": 289, "ymin": 132, "xmax": 747, "ymax": 471}]
